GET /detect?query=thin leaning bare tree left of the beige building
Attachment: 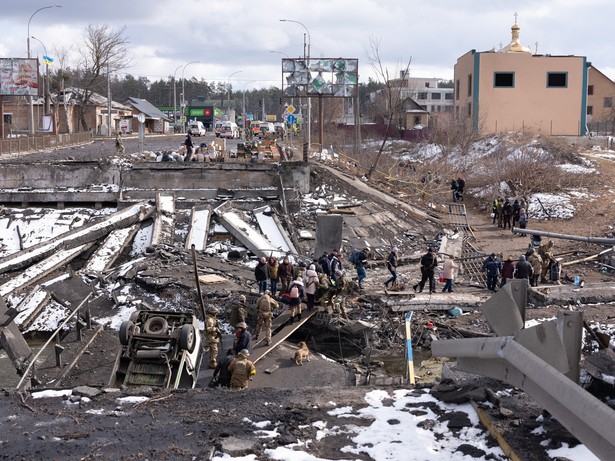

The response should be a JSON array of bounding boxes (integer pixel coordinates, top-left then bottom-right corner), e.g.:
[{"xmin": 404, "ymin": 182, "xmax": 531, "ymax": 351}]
[{"xmin": 365, "ymin": 37, "xmax": 412, "ymax": 179}]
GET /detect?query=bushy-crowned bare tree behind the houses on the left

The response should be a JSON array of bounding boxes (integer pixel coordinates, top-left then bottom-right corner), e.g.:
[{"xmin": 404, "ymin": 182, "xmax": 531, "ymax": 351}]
[{"xmin": 78, "ymin": 24, "xmax": 129, "ymax": 131}]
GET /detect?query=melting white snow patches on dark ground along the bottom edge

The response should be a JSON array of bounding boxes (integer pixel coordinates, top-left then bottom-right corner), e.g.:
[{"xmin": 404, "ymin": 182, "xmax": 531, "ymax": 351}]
[{"xmin": 207, "ymin": 390, "xmax": 597, "ymax": 461}]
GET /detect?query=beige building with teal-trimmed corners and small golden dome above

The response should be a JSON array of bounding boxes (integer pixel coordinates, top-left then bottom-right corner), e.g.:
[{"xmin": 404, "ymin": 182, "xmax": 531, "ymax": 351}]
[{"xmin": 454, "ymin": 21, "xmax": 589, "ymax": 136}]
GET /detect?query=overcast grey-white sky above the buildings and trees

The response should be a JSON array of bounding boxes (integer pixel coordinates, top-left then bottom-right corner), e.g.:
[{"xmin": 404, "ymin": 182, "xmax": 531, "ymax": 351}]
[{"xmin": 0, "ymin": 0, "xmax": 615, "ymax": 90}]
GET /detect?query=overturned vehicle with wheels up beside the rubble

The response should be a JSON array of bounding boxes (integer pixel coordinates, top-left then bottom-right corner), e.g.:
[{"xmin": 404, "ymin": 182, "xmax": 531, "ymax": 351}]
[{"xmin": 109, "ymin": 310, "xmax": 203, "ymax": 389}]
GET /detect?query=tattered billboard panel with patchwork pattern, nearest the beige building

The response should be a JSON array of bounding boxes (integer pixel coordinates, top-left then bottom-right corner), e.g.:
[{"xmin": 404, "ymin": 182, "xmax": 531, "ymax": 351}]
[{"xmin": 282, "ymin": 58, "xmax": 359, "ymax": 98}]
